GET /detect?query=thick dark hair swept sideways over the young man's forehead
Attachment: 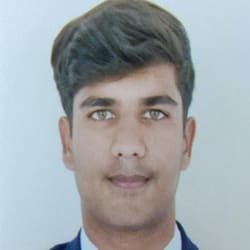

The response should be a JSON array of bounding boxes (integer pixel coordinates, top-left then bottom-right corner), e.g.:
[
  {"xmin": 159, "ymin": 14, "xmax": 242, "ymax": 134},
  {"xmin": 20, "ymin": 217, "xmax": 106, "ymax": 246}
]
[{"xmin": 51, "ymin": 0, "xmax": 194, "ymax": 120}]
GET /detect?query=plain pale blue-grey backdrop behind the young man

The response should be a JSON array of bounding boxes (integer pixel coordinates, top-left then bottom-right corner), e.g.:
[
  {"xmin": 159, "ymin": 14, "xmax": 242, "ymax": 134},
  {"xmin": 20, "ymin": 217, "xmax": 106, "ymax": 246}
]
[{"xmin": 0, "ymin": 0, "xmax": 250, "ymax": 250}]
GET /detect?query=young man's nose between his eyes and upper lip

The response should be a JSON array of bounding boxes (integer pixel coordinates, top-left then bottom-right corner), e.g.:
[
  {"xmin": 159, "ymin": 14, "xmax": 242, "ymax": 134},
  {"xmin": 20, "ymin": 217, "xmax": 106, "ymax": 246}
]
[{"xmin": 111, "ymin": 121, "xmax": 146, "ymax": 158}]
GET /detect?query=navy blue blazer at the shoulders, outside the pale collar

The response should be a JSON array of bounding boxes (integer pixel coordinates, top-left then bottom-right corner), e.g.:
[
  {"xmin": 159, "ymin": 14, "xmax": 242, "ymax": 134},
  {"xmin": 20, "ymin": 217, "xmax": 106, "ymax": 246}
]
[{"xmin": 50, "ymin": 222, "xmax": 198, "ymax": 250}]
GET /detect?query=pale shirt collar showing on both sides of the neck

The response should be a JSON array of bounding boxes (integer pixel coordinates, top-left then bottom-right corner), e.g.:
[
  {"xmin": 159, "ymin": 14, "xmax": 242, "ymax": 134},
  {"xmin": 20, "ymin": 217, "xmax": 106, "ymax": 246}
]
[{"xmin": 80, "ymin": 224, "xmax": 181, "ymax": 250}]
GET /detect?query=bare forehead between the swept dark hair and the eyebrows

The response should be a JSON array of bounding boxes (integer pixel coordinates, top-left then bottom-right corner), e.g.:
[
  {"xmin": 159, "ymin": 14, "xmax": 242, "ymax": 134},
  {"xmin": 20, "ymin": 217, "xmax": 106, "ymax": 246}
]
[{"xmin": 74, "ymin": 64, "xmax": 181, "ymax": 106}]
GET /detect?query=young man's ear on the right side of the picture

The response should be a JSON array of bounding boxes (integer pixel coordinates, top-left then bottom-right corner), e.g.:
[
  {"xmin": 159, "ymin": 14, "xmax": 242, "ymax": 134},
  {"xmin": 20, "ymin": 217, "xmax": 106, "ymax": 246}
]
[{"xmin": 182, "ymin": 117, "xmax": 196, "ymax": 169}]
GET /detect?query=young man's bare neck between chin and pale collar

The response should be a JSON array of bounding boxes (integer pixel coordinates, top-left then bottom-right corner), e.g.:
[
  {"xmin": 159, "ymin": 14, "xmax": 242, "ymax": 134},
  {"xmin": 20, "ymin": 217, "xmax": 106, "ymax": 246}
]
[{"xmin": 82, "ymin": 206, "xmax": 175, "ymax": 250}]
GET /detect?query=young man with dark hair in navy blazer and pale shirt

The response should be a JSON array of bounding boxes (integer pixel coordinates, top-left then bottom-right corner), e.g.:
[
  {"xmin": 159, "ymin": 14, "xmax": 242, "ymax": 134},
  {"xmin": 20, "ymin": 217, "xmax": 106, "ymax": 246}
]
[{"xmin": 52, "ymin": 0, "xmax": 198, "ymax": 250}]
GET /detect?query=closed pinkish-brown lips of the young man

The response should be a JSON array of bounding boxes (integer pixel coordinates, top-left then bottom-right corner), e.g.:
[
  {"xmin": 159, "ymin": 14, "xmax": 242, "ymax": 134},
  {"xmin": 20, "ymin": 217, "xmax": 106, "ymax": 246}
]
[{"xmin": 108, "ymin": 175, "xmax": 150, "ymax": 189}]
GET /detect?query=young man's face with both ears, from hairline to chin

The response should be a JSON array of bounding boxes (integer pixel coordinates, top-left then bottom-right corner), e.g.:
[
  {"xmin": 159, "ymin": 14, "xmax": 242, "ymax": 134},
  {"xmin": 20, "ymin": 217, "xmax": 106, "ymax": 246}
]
[{"xmin": 59, "ymin": 64, "xmax": 195, "ymax": 229}]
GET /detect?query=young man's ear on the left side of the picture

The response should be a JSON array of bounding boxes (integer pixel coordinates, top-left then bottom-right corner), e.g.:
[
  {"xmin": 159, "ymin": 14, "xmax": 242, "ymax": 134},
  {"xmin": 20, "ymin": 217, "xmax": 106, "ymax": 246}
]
[{"xmin": 58, "ymin": 117, "xmax": 74, "ymax": 171}]
